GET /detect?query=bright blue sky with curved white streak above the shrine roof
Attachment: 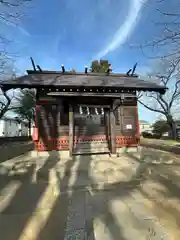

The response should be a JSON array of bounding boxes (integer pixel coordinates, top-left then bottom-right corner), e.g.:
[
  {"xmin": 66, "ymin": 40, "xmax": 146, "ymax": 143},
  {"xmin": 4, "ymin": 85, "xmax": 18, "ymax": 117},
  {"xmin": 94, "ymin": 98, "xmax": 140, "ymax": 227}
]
[{"xmin": 0, "ymin": 0, "xmax": 177, "ymax": 122}]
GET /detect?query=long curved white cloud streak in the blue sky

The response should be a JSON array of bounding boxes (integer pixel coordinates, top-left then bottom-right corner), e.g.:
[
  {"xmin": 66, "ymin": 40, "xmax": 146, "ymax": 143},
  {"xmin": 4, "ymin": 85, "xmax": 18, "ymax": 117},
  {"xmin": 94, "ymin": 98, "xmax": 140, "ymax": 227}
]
[{"xmin": 94, "ymin": 0, "xmax": 147, "ymax": 59}]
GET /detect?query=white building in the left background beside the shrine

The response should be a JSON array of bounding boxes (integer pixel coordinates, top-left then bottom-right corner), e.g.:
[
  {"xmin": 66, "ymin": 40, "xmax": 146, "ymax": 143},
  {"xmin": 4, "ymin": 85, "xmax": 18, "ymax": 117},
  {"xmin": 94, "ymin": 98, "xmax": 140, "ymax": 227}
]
[{"xmin": 0, "ymin": 117, "xmax": 28, "ymax": 137}]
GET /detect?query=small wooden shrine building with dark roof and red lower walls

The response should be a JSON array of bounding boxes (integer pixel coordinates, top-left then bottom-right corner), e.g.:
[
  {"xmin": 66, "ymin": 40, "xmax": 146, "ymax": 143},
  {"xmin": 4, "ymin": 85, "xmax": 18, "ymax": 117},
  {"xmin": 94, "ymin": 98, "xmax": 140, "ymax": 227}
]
[{"xmin": 1, "ymin": 64, "xmax": 166, "ymax": 155}]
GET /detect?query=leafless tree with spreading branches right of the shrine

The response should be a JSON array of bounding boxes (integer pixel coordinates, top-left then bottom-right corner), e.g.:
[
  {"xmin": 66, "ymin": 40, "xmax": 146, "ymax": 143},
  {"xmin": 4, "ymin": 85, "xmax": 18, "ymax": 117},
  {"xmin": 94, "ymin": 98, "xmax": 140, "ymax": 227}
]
[{"xmin": 138, "ymin": 58, "xmax": 180, "ymax": 139}]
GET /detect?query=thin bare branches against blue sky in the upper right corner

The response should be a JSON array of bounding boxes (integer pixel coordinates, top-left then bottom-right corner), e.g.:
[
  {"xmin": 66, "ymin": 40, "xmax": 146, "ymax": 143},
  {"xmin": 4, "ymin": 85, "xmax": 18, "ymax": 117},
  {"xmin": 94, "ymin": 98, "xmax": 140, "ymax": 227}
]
[{"xmin": 141, "ymin": 0, "xmax": 180, "ymax": 58}]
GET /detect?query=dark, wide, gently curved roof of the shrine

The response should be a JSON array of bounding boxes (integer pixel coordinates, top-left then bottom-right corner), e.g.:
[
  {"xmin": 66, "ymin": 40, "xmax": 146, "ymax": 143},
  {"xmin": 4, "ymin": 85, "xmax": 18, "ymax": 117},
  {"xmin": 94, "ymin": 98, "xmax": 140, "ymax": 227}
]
[{"xmin": 1, "ymin": 72, "xmax": 165, "ymax": 91}]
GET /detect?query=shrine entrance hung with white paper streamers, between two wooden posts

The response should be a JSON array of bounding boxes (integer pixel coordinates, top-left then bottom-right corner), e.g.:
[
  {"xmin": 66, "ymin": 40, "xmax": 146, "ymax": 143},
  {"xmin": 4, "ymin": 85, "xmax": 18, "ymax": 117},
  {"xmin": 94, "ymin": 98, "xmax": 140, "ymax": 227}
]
[{"xmin": 73, "ymin": 105, "xmax": 109, "ymax": 154}]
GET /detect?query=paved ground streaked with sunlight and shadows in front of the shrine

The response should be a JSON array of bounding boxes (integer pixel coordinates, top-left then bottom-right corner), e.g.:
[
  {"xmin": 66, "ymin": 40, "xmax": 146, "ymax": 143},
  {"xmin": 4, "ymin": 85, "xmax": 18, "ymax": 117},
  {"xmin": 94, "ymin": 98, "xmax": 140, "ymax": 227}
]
[{"xmin": 0, "ymin": 151, "xmax": 180, "ymax": 240}]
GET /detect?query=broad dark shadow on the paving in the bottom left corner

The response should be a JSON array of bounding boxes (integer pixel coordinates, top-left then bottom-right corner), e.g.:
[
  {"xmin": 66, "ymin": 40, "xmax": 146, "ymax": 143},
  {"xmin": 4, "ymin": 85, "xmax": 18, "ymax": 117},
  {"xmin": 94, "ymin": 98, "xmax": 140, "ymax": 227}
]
[{"xmin": 0, "ymin": 161, "xmax": 45, "ymax": 240}]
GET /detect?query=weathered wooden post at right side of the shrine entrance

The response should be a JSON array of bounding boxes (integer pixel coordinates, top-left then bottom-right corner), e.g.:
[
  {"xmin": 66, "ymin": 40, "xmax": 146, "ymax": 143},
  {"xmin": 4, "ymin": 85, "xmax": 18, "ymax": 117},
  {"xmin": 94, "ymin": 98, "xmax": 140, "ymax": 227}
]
[{"xmin": 109, "ymin": 103, "xmax": 116, "ymax": 154}]
